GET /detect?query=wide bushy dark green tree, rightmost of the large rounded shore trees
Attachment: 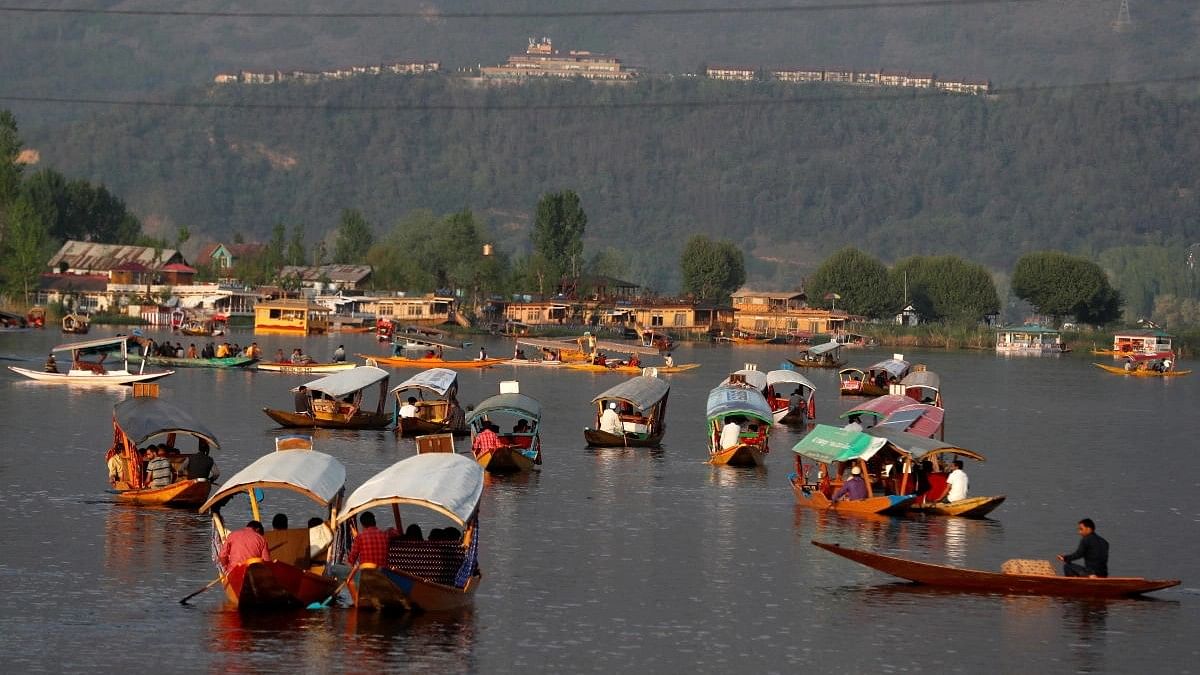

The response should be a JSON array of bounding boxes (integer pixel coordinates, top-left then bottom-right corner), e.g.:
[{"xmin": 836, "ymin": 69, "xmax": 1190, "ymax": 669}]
[{"xmin": 1013, "ymin": 251, "xmax": 1122, "ymax": 324}]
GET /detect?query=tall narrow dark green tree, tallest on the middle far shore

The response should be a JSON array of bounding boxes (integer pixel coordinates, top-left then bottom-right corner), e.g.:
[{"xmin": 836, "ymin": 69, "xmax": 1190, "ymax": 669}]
[{"xmin": 532, "ymin": 190, "xmax": 588, "ymax": 293}]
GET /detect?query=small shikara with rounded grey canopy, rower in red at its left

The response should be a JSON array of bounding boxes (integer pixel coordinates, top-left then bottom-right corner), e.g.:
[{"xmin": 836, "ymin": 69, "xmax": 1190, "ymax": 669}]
[{"xmin": 467, "ymin": 382, "xmax": 541, "ymax": 473}]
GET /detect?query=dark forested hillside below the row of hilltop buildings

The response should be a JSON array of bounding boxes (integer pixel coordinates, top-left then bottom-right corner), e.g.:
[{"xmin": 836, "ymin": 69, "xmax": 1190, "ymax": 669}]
[{"xmin": 18, "ymin": 77, "xmax": 1200, "ymax": 288}]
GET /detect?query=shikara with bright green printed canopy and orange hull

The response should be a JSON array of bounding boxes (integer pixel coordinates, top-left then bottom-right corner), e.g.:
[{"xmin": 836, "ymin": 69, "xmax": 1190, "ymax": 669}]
[{"xmin": 790, "ymin": 424, "xmax": 917, "ymax": 514}]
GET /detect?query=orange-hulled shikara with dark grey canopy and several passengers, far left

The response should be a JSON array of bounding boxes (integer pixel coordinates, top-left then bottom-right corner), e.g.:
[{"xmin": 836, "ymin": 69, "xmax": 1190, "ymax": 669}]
[{"xmin": 104, "ymin": 384, "xmax": 221, "ymax": 508}]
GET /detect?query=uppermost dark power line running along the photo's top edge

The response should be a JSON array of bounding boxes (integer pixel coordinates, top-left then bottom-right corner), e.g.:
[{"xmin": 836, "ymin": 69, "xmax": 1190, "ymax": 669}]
[{"xmin": 0, "ymin": 0, "xmax": 1089, "ymax": 19}]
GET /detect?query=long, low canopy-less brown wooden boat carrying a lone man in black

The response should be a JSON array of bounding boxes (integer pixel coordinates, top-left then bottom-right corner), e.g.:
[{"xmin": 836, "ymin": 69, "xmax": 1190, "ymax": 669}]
[{"xmin": 812, "ymin": 540, "xmax": 1180, "ymax": 598}]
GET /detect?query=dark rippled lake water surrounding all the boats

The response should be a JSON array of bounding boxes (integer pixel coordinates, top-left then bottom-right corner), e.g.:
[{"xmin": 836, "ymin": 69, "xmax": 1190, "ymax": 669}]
[{"xmin": 0, "ymin": 327, "xmax": 1200, "ymax": 673}]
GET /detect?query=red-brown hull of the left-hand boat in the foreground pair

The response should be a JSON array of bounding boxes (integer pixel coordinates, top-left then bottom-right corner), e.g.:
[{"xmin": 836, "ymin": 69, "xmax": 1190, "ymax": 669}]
[{"xmin": 222, "ymin": 558, "xmax": 338, "ymax": 610}]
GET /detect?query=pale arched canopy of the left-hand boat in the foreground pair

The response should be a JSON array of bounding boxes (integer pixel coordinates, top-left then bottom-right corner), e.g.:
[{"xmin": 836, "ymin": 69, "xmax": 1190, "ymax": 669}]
[{"xmin": 200, "ymin": 450, "xmax": 346, "ymax": 513}]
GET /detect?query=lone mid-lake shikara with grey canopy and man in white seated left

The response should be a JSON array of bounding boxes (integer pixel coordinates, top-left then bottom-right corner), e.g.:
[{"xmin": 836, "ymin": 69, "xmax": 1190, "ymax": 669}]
[{"xmin": 583, "ymin": 375, "xmax": 671, "ymax": 448}]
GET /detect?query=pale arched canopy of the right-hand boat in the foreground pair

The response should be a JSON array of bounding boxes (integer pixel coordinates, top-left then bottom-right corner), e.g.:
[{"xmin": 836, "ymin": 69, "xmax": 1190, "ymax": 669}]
[{"xmin": 337, "ymin": 453, "xmax": 484, "ymax": 526}]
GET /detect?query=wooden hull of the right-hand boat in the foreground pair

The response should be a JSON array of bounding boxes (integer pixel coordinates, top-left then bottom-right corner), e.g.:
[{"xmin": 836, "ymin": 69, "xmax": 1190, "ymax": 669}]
[{"xmin": 349, "ymin": 566, "xmax": 480, "ymax": 611}]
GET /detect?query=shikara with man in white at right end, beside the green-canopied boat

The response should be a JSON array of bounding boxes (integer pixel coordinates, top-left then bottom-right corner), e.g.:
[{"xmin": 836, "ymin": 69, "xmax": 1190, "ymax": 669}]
[{"xmin": 868, "ymin": 428, "xmax": 1004, "ymax": 518}]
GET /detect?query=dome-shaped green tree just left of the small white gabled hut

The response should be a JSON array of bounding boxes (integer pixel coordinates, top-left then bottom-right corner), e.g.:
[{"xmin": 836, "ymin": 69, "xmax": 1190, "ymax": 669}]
[{"xmin": 804, "ymin": 246, "xmax": 902, "ymax": 318}]
